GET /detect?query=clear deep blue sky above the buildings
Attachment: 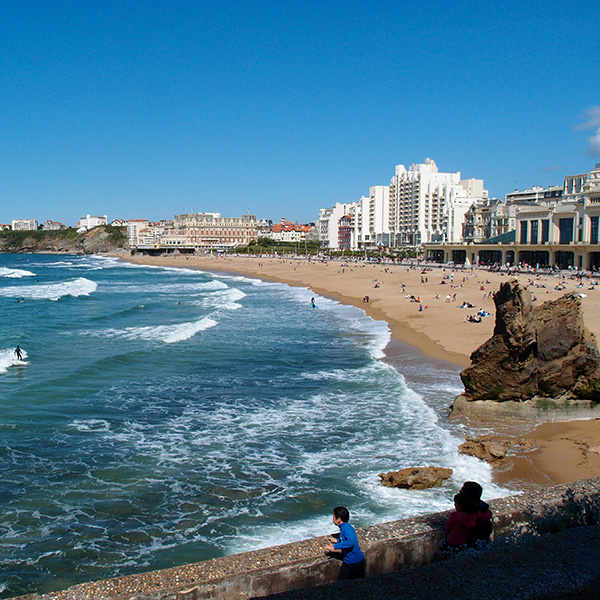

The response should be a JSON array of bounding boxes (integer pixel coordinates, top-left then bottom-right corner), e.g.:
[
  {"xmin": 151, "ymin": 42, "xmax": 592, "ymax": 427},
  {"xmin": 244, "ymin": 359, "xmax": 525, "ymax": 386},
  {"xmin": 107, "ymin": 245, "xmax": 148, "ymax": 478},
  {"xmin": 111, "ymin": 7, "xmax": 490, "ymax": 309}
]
[{"xmin": 0, "ymin": 0, "xmax": 600, "ymax": 225}]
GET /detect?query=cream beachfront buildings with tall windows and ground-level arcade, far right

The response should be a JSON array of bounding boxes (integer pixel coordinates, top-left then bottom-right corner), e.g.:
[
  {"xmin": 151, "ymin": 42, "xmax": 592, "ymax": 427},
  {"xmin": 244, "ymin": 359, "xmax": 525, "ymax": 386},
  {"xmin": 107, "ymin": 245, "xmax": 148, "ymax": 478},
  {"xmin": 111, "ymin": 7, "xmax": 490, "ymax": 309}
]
[{"xmin": 425, "ymin": 163, "xmax": 600, "ymax": 270}]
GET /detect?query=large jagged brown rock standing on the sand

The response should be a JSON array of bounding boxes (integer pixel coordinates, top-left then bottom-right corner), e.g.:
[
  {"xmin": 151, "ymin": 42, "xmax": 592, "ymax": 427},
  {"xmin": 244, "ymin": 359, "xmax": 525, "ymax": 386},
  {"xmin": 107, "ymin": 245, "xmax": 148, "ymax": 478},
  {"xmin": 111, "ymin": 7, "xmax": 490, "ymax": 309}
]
[{"xmin": 461, "ymin": 280, "xmax": 600, "ymax": 403}]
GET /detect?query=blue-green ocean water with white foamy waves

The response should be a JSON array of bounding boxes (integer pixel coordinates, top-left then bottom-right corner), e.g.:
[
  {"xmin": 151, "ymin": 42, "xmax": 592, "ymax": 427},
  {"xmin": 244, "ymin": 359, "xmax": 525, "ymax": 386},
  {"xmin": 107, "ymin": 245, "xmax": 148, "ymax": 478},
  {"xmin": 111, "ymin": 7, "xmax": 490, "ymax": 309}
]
[{"xmin": 0, "ymin": 255, "xmax": 503, "ymax": 597}]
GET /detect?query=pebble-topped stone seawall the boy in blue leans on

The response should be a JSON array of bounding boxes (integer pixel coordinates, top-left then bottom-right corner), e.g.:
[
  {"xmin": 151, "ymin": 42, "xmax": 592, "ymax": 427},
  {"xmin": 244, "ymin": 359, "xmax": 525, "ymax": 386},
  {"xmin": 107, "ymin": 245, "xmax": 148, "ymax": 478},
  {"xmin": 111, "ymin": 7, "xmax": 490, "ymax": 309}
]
[{"xmin": 12, "ymin": 477, "xmax": 600, "ymax": 600}]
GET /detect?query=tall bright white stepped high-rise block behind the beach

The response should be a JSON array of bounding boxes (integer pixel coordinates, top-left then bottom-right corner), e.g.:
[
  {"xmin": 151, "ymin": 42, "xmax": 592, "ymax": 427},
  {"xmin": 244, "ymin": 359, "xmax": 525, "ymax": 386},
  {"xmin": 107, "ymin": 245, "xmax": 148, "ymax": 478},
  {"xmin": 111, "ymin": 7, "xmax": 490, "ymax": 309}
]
[{"xmin": 319, "ymin": 158, "xmax": 488, "ymax": 250}]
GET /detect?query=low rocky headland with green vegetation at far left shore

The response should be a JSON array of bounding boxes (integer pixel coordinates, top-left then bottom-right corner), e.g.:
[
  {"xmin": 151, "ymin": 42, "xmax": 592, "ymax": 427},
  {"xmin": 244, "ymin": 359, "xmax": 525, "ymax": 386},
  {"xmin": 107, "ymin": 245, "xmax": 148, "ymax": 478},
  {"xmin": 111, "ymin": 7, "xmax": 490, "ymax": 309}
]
[{"xmin": 0, "ymin": 225, "xmax": 129, "ymax": 254}]
